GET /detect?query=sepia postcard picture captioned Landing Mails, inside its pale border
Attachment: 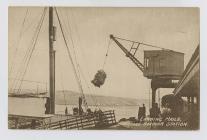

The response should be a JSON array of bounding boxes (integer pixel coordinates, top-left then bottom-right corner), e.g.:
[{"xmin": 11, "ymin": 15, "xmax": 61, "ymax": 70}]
[{"xmin": 6, "ymin": 6, "xmax": 200, "ymax": 130}]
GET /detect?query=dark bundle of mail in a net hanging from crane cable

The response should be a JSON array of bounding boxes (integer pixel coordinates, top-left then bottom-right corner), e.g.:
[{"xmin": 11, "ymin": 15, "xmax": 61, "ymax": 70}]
[{"xmin": 91, "ymin": 70, "xmax": 106, "ymax": 88}]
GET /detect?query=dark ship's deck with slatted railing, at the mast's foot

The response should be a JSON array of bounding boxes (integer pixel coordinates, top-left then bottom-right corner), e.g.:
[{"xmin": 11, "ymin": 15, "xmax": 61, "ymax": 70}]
[{"xmin": 9, "ymin": 110, "xmax": 117, "ymax": 130}]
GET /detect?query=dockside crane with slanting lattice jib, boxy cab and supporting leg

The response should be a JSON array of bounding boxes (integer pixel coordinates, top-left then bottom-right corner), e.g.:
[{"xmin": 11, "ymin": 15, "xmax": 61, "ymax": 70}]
[{"xmin": 110, "ymin": 34, "xmax": 184, "ymax": 117}]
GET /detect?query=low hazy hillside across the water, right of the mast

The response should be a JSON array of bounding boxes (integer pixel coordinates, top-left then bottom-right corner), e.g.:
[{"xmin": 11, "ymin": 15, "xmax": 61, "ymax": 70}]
[{"xmin": 56, "ymin": 91, "xmax": 147, "ymax": 106}]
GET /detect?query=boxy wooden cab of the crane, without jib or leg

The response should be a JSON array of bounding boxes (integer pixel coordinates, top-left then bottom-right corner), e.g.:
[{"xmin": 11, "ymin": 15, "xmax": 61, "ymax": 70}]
[{"xmin": 144, "ymin": 50, "xmax": 184, "ymax": 80}]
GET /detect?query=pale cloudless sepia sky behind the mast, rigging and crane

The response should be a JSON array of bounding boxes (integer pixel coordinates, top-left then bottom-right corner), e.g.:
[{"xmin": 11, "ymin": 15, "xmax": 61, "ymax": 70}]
[{"xmin": 8, "ymin": 7, "xmax": 200, "ymax": 99}]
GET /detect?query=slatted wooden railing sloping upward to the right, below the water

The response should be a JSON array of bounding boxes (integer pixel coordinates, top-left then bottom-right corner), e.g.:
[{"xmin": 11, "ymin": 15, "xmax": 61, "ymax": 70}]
[{"xmin": 36, "ymin": 110, "xmax": 116, "ymax": 129}]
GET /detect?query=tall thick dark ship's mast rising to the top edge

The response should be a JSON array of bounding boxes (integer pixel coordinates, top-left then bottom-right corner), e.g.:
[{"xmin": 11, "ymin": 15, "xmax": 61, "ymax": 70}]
[{"xmin": 49, "ymin": 7, "xmax": 55, "ymax": 114}]
